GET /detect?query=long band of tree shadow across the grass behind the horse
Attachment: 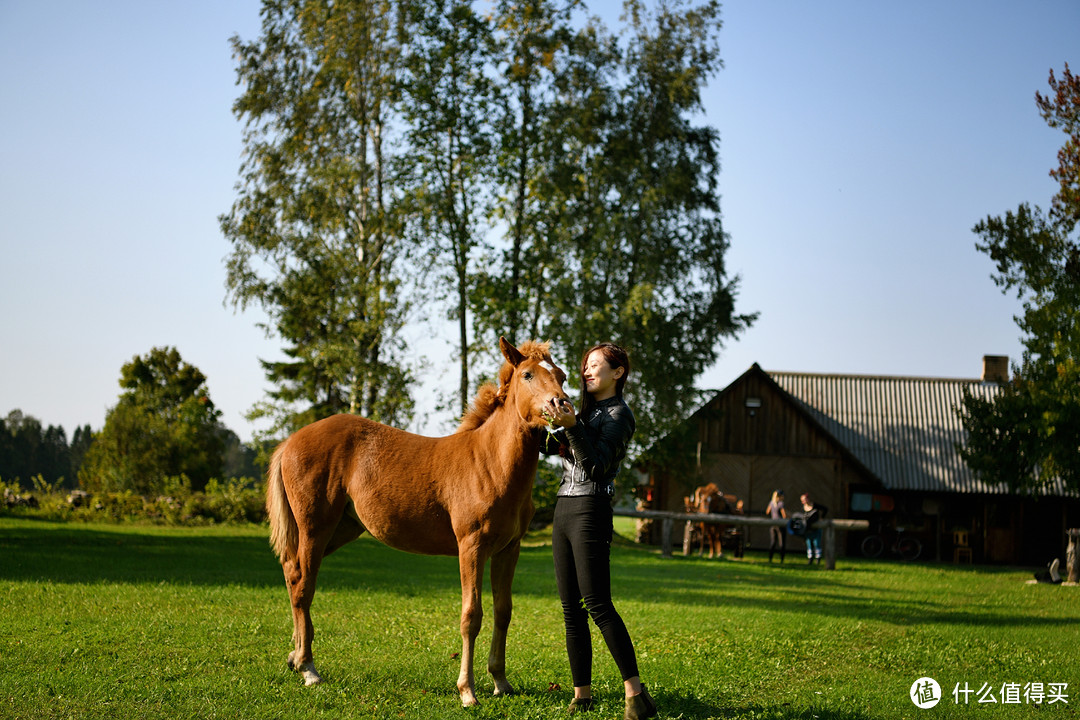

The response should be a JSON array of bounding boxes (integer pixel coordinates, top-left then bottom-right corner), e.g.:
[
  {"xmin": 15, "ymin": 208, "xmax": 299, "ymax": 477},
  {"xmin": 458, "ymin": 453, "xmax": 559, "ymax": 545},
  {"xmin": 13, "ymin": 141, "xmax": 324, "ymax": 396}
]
[{"xmin": 0, "ymin": 521, "xmax": 1078, "ymax": 628}]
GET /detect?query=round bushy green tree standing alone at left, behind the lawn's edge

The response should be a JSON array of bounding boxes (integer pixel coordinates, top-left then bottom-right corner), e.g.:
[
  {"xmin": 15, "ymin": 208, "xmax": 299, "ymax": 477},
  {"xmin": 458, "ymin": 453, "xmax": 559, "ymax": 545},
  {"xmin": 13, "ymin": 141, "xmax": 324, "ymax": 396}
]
[{"xmin": 79, "ymin": 348, "xmax": 222, "ymax": 494}]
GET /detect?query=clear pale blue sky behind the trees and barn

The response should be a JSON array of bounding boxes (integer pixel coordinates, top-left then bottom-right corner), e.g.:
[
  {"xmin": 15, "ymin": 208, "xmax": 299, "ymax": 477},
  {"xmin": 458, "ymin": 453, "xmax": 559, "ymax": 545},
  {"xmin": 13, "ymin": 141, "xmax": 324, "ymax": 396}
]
[{"xmin": 0, "ymin": 0, "xmax": 1080, "ymax": 439}]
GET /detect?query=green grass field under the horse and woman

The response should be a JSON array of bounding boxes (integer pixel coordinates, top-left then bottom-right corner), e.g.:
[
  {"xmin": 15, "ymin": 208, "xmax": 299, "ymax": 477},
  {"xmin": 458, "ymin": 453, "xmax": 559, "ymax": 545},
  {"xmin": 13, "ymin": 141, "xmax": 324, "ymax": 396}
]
[{"xmin": 0, "ymin": 518, "xmax": 1080, "ymax": 720}]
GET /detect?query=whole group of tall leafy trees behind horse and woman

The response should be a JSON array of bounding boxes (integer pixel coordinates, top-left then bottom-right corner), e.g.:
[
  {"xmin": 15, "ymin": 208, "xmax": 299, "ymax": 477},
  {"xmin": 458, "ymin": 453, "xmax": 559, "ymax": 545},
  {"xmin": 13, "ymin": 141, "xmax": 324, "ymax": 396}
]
[{"xmin": 220, "ymin": 0, "xmax": 755, "ymax": 446}]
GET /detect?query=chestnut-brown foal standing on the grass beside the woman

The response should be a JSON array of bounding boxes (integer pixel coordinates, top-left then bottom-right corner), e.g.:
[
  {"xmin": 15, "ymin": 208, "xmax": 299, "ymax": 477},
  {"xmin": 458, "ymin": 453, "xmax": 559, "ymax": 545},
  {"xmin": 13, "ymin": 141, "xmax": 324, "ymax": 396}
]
[{"xmin": 267, "ymin": 338, "xmax": 567, "ymax": 706}]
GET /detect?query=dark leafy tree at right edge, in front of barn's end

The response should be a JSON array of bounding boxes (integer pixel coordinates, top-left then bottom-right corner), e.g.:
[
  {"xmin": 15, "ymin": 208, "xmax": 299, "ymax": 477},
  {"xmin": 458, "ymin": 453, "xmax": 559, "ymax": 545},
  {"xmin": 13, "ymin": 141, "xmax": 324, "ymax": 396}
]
[{"xmin": 960, "ymin": 64, "xmax": 1080, "ymax": 490}]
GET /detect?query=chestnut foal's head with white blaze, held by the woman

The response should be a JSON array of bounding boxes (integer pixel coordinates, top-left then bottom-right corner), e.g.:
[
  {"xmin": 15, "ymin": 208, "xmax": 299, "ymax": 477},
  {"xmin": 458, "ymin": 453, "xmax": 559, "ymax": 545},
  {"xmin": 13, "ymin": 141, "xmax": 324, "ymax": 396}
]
[{"xmin": 499, "ymin": 338, "xmax": 569, "ymax": 427}]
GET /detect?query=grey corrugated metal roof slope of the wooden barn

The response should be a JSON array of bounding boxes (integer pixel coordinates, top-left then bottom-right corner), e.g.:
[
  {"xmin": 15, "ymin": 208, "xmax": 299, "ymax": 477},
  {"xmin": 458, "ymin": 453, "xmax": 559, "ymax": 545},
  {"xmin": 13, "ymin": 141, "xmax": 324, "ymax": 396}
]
[{"xmin": 767, "ymin": 371, "xmax": 1008, "ymax": 493}]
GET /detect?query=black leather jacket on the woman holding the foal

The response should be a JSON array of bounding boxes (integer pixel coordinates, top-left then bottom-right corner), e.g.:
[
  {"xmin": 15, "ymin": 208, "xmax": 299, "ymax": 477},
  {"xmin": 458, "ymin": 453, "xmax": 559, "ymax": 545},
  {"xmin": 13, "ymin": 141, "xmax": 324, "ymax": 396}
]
[{"xmin": 540, "ymin": 396, "xmax": 637, "ymax": 498}]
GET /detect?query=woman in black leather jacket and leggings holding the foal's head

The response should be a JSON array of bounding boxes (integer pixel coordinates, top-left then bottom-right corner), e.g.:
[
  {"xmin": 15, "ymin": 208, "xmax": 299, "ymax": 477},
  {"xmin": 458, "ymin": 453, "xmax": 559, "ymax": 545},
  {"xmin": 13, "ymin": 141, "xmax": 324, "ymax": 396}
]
[{"xmin": 543, "ymin": 342, "xmax": 657, "ymax": 720}]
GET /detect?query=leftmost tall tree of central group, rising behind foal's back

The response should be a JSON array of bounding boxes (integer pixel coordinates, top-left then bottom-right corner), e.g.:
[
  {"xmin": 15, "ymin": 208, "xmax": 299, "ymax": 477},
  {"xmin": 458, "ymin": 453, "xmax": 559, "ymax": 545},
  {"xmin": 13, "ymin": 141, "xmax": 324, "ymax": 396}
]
[{"xmin": 220, "ymin": 0, "xmax": 413, "ymax": 440}]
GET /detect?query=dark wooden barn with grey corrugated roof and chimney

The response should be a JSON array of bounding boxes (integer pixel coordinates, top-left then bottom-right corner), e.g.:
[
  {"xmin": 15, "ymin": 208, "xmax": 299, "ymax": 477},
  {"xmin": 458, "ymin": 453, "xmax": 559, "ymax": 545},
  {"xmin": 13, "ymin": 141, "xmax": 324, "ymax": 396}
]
[{"xmin": 637, "ymin": 355, "xmax": 1080, "ymax": 566}]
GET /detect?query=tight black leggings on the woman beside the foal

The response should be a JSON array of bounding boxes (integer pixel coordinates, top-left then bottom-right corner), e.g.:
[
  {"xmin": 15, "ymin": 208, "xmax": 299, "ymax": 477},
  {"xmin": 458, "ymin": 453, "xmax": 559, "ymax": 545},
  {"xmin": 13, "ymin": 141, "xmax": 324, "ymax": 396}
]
[{"xmin": 551, "ymin": 497, "xmax": 637, "ymax": 688}]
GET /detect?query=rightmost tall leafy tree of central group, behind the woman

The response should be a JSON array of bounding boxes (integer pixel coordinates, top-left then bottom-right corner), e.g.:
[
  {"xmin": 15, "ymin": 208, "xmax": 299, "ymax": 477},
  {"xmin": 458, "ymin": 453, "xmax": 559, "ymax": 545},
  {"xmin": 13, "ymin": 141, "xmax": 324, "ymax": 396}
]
[{"xmin": 527, "ymin": 0, "xmax": 756, "ymax": 445}]
